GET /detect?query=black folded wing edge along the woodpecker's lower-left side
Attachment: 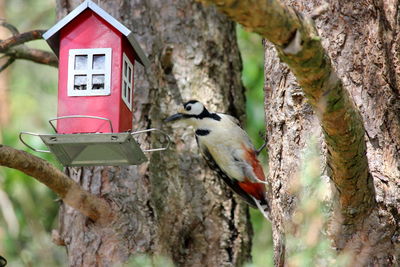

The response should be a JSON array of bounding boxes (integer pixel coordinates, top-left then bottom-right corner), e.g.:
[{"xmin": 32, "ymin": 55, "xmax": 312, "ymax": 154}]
[{"xmin": 196, "ymin": 138, "xmax": 257, "ymax": 208}]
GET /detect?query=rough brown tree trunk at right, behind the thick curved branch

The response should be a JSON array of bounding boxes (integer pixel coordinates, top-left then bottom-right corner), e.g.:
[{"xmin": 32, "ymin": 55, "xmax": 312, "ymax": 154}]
[{"xmin": 265, "ymin": 0, "xmax": 400, "ymax": 266}]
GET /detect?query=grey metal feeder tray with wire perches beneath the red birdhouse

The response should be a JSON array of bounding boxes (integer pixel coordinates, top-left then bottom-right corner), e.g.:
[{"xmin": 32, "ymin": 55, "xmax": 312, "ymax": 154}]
[{"xmin": 19, "ymin": 120, "xmax": 170, "ymax": 166}]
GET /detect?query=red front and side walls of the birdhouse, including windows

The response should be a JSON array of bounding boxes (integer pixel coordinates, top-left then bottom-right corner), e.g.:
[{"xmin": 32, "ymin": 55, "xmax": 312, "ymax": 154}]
[{"xmin": 57, "ymin": 9, "xmax": 135, "ymax": 134}]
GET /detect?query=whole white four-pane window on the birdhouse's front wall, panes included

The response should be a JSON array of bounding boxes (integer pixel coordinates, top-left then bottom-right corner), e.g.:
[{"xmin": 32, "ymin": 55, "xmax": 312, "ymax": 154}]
[{"xmin": 68, "ymin": 48, "xmax": 111, "ymax": 96}]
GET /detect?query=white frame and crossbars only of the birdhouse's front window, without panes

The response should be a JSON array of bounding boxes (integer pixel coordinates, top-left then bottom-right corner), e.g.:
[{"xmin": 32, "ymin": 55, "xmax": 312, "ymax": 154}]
[{"xmin": 68, "ymin": 48, "xmax": 112, "ymax": 96}]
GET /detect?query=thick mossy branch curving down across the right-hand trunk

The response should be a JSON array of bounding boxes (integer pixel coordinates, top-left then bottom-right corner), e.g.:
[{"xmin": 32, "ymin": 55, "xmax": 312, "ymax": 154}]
[{"xmin": 202, "ymin": 0, "xmax": 375, "ymax": 237}]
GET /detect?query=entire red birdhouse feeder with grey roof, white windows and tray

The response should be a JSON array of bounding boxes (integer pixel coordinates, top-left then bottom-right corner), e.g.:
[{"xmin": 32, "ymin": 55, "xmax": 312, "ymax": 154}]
[{"xmin": 21, "ymin": 0, "xmax": 169, "ymax": 166}]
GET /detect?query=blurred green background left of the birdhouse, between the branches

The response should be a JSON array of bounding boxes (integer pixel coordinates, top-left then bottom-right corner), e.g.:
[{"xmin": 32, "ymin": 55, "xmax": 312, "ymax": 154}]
[{"xmin": 0, "ymin": 0, "xmax": 65, "ymax": 266}]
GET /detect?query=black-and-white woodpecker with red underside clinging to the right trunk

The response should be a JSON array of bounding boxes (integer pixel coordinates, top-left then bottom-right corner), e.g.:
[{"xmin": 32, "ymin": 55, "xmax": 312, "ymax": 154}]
[{"xmin": 165, "ymin": 100, "xmax": 269, "ymax": 219}]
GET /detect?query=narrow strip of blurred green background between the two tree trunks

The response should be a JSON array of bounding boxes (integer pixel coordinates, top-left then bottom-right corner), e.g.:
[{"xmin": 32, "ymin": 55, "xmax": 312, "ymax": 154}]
[{"xmin": 236, "ymin": 25, "xmax": 273, "ymax": 267}]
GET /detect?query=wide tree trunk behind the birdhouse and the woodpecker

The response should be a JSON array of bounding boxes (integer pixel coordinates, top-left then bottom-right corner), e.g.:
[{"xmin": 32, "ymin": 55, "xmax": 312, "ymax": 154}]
[{"xmin": 54, "ymin": 0, "xmax": 252, "ymax": 266}]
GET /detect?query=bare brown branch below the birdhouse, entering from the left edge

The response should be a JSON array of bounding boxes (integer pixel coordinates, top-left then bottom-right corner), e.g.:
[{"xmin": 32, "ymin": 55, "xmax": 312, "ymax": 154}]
[{"xmin": 0, "ymin": 144, "xmax": 113, "ymax": 222}]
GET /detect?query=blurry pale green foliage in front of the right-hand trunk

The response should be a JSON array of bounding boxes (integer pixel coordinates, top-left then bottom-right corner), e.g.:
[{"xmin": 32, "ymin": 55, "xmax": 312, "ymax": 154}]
[{"xmin": 286, "ymin": 137, "xmax": 347, "ymax": 267}]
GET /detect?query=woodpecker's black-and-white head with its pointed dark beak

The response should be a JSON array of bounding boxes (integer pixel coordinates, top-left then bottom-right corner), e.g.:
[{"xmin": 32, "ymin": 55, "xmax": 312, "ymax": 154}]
[{"xmin": 164, "ymin": 100, "xmax": 209, "ymax": 125}]
